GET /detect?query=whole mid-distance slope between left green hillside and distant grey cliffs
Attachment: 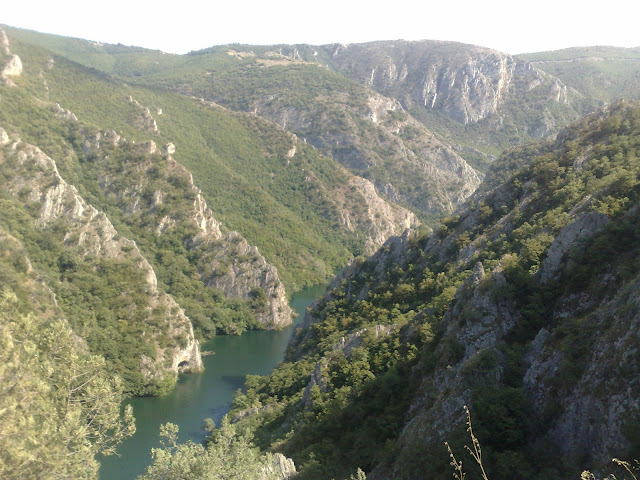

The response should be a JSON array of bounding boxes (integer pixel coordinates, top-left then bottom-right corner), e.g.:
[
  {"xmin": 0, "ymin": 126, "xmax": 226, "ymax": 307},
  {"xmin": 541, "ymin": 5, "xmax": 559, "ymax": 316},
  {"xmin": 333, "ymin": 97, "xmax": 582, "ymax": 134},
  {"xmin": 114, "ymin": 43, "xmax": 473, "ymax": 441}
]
[{"xmin": 165, "ymin": 46, "xmax": 480, "ymax": 219}]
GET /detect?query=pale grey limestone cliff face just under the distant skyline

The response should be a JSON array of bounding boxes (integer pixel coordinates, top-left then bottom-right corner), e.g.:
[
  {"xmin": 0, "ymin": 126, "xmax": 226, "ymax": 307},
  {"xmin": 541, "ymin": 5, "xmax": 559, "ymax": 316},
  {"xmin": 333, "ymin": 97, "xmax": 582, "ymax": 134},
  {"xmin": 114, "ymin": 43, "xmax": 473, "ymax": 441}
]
[{"xmin": 325, "ymin": 41, "xmax": 569, "ymax": 136}]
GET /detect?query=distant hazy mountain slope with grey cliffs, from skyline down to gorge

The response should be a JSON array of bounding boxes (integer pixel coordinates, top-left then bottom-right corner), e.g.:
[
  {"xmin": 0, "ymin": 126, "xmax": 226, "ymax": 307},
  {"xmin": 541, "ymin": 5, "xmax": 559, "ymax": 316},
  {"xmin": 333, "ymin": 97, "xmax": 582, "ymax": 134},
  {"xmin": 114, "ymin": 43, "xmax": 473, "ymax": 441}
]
[{"xmin": 323, "ymin": 41, "xmax": 586, "ymax": 165}]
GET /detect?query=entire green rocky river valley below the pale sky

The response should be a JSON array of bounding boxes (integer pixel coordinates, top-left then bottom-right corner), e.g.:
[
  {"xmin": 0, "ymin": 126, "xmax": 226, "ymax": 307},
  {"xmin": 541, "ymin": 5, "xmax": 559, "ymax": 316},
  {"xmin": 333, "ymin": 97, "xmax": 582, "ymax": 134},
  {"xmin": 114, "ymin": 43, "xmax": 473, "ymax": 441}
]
[{"xmin": 0, "ymin": 26, "xmax": 640, "ymax": 480}]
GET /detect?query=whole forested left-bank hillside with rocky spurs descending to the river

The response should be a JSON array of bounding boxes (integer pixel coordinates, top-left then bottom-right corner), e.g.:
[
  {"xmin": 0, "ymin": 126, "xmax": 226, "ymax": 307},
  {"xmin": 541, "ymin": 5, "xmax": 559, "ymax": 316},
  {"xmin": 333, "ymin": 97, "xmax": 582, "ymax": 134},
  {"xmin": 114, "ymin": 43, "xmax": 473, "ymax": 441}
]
[{"xmin": 0, "ymin": 24, "xmax": 417, "ymax": 400}]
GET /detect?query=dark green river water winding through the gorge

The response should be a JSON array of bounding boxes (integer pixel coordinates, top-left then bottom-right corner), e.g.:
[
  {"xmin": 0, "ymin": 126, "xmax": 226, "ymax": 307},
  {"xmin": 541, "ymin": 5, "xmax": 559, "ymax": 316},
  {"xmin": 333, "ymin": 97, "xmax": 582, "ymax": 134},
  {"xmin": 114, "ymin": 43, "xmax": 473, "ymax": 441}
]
[{"xmin": 100, "ymin": 285, "xmax": 325, "ymax": 480}]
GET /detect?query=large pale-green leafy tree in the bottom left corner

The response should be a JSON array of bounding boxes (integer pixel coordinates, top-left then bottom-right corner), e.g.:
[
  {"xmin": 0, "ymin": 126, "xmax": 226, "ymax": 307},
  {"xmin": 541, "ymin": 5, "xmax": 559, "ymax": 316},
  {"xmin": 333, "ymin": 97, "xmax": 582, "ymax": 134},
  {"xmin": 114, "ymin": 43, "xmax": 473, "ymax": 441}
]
[{"xmin": 0, "ymin": 289, "xmax": 135, "ymax": 480}]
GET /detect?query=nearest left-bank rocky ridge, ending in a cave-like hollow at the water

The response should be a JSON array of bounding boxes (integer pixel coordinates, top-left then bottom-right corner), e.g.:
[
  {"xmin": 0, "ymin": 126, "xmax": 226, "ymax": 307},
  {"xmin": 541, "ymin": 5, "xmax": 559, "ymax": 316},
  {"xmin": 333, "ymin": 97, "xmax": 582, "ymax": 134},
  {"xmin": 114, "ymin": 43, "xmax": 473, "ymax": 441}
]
[{"xmin": 0, "ymin": 129, "xmax": 202, "ymax": 394}]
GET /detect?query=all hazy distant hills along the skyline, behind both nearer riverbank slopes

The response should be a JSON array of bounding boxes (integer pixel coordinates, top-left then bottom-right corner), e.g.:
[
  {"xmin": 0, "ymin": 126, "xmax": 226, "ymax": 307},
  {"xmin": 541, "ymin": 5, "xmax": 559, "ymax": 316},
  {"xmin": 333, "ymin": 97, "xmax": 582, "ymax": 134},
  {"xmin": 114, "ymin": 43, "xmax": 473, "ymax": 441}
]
[{"xmin": 8, "ymin": 30, "xmax": 640, "ymax": 219}]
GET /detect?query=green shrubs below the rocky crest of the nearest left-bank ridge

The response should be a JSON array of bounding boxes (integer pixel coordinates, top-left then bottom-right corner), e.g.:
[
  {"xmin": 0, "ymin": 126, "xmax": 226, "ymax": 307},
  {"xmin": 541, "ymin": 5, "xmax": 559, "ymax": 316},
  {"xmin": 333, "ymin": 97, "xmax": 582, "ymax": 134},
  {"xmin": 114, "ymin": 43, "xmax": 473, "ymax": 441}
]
[{"xmin": 0, "ymin": 129, "xmax": 192, "ymax": 394}]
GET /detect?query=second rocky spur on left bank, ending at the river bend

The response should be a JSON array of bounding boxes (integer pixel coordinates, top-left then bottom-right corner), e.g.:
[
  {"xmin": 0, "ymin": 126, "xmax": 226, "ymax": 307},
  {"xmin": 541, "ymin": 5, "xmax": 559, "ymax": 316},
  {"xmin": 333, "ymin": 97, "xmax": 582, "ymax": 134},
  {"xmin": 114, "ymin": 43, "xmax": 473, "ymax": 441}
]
[{"xmin": 77, "ymin": 131, "xmax": 292, "ymax": 328}]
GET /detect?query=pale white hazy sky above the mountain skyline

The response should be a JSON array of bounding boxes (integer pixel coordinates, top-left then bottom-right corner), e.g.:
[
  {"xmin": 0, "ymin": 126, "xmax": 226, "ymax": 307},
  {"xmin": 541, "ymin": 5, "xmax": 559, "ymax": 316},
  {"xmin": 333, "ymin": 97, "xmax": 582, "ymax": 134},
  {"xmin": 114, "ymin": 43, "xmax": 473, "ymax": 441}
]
[{"xmin": 0, "ymin": 0, "xmax": 640, "ymax": 53}]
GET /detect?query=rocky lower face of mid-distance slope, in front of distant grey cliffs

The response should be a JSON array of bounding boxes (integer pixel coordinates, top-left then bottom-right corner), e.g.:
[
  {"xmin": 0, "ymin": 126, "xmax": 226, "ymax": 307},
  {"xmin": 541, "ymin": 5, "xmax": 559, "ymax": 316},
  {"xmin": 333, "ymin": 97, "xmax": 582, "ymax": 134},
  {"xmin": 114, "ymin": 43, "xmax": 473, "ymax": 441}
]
[{"xmin": 248, "ymin": 86, "xmax": 481, "ymax": 218}]
